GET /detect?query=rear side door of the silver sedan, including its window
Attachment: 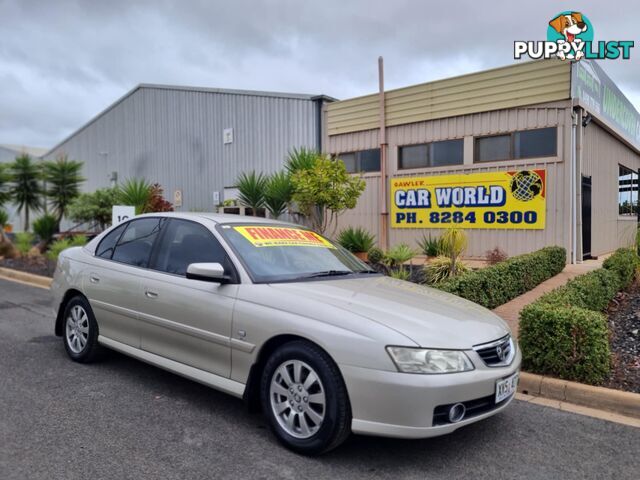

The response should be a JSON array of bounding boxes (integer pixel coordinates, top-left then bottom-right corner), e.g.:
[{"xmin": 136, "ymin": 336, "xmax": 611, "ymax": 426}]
[{"xmin": 83, "ymin": 217, "xmax": 166, "ymax": 348}]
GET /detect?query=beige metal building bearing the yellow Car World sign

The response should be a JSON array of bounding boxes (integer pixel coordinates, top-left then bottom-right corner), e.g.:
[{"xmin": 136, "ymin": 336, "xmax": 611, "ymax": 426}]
[{"xmin": 325, "ymin": 60, "xmax": 640, "ymax": 261}]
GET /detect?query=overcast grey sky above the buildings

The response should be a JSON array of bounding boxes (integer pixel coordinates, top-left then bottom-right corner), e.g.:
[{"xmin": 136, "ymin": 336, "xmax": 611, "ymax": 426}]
[{"xmin": 0, "ymin": 0, "xmax": 640, "ymax": 147}]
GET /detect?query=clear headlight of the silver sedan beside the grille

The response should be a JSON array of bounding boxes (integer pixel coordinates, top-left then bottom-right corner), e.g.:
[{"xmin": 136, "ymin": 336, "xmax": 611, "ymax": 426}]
[{"xmin": 387, "ymin": 347, "xmax": 474, "ymax": 373}]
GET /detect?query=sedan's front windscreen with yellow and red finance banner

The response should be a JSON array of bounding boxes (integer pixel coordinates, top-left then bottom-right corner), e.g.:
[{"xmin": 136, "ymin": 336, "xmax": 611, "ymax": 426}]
[{"xmin": 219, "ymin": 224, "xmax": 374, "ymax": 283}]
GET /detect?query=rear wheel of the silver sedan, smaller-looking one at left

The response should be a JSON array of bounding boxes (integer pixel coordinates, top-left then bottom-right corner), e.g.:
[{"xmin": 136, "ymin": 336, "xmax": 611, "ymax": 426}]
[{"xmin": 62, "ymin": 295, "xmax": 102, "ymax": 363}]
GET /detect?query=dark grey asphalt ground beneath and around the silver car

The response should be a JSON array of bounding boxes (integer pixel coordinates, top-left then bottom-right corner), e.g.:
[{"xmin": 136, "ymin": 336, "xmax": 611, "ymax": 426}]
[{"xmin": 0, "ymin": 280, "xmax": 640, "ymax": 480}]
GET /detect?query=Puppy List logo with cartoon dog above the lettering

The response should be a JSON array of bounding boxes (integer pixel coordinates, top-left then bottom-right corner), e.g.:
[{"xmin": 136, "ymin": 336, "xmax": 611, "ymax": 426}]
[{"xmin": 513, "ymin": 10, "xmax": 634, "ymax": 61}]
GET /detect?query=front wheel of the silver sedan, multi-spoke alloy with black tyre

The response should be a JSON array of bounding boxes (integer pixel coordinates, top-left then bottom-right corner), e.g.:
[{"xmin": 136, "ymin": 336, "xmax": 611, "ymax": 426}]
[{"xmin": 261, "ymin": 341, "xmax": 351, "ymax": 455}]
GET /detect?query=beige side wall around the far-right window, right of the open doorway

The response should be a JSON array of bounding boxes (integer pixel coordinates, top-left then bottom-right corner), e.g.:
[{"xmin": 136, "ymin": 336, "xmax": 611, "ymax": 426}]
[{"xmin": 581, "ymin": 121, "xmax": 640, "ymax": 255}]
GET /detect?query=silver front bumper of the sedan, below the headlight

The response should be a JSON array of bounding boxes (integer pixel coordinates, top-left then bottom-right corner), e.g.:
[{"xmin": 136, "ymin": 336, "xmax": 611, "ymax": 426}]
[{"xmin": 340, "ymin": 349, "xmax": 522, "ymax": 438}]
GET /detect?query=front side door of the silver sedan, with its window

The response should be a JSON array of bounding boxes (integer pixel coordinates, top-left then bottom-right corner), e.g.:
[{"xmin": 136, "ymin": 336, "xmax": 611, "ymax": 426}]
[{"xmin": 139, "ymin": 218, "xmax": 238, "ymax": 377}]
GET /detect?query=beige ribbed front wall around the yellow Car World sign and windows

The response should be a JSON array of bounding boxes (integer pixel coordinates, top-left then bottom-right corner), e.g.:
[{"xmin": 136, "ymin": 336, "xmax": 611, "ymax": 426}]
[{"xmin": 326, "ymin": 101, "xmax": 571, "ymax": 257}]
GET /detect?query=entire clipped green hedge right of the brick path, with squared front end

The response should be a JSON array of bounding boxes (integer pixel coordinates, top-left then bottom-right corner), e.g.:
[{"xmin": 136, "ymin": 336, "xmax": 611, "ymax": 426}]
[{"xmin": 520, "ymin": 249, "xmax": 638, "ymax": 384}]
